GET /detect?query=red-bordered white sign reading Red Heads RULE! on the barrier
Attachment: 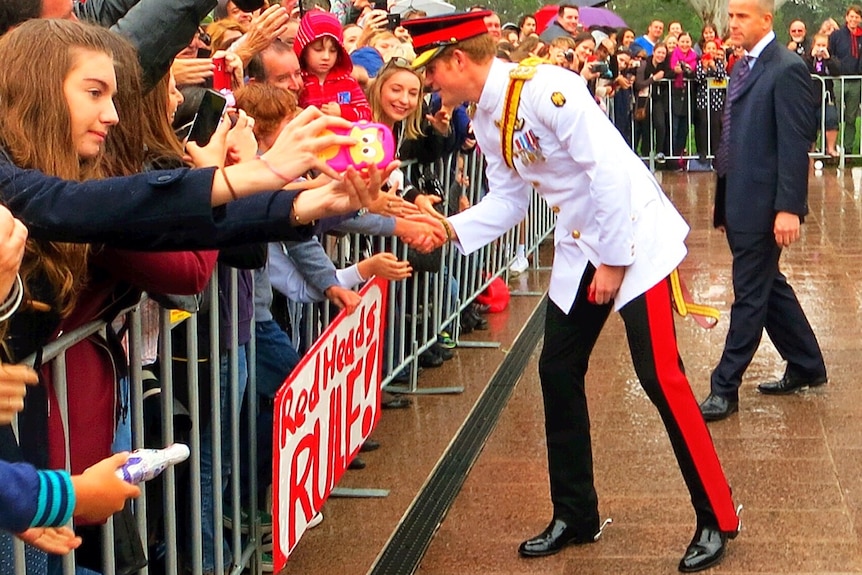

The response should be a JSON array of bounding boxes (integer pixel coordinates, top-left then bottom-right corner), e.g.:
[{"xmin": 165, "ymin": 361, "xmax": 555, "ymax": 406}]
[{"xmin": 272, "ymin": 278, "xmax": 388, "ymax": 571}]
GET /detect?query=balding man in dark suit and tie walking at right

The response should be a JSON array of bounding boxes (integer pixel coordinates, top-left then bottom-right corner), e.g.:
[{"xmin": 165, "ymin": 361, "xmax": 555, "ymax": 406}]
[{"xmin": 700, "ymin": 0, "xmax": 826, "ymax": 421}]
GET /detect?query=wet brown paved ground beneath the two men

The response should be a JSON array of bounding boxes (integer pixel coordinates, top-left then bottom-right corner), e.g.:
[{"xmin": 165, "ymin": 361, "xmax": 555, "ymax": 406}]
[{"xmin": 284, "ymin": 164, "xmax": 862, "ymax": 575}]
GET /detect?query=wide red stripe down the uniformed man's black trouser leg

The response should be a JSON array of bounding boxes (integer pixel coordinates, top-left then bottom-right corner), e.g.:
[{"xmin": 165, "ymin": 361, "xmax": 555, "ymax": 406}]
[{"xmin": 644, "ymin": 281, "xmax": 739, "ymax": 531}]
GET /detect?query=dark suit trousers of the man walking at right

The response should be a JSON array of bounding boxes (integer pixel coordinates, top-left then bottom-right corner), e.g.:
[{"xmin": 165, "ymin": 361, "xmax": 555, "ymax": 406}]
[{"xmin": 711, "ymin": 228, "xmax": 826, "ymax": 400}]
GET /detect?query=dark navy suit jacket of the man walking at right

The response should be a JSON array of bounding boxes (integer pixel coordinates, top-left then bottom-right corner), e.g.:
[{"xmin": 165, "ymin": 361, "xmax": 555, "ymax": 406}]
[{"xmin": 715, "ymin": 40, "xmax": 817, "ymax": 233}]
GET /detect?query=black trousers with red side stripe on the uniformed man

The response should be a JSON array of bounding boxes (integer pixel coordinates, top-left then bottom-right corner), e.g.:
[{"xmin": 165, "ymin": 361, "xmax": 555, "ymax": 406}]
[{"xmin": 539, "ymin": 266, "xmax": 738, "ymax": 536}]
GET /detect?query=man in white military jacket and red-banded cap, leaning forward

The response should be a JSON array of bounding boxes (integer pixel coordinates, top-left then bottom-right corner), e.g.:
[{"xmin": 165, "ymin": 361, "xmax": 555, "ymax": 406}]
[{"xmin": 404, "ymin": 12, "xmax": 739, "ymax": 572}]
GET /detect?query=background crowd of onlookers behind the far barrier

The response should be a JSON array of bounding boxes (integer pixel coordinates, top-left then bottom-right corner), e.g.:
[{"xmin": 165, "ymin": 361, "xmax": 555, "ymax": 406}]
[{"xmin": 489, "ymin": 3, "xmax": 862, "ymax": 165}]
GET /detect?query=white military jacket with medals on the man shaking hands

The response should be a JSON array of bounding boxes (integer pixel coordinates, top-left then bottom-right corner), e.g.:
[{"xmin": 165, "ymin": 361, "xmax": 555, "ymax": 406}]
[{"xmin": 450, "ymin": 60, "xmax": 689, "ymax": 311}]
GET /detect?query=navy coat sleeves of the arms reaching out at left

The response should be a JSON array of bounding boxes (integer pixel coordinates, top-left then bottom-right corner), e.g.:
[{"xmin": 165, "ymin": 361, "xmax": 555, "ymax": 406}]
[{"xmin": 0, "ymin": 159, "xmax": 311, "ymax": 251}]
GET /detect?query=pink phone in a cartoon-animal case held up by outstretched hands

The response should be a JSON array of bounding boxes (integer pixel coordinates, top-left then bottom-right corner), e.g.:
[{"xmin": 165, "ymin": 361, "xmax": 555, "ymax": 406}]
[{"xmin": 320, "ymin": 120, "xmax": 395, "ymax": 172}]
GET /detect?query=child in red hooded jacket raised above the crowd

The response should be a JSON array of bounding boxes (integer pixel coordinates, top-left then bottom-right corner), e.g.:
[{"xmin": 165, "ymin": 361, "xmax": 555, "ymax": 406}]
[{"xmin": 293, "ymin": 10, "xmax": 371, "ymax": 121}]
